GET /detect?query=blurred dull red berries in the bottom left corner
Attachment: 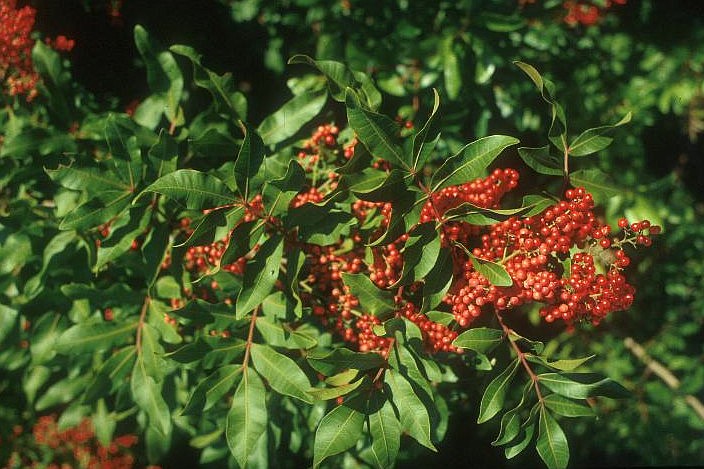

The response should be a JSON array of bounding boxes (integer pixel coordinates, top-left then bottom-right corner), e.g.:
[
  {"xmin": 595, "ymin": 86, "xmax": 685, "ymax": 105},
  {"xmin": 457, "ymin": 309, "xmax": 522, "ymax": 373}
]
[{"xmin": 2, "ymin": 415, "xmax": 147, "ymax": 469}]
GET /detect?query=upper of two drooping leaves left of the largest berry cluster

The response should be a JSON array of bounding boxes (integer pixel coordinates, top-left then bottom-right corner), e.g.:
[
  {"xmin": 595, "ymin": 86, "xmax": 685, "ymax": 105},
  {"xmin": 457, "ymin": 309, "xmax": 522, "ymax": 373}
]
[{"xmin": 392, "ymin": 222, "xmax": 441, "ymax": 286}]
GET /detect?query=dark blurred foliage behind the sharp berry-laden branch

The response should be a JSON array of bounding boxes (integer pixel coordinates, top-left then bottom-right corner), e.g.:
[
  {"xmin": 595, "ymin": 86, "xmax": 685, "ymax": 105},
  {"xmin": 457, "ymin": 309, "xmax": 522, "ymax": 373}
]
[{"xmin": 0, "ymin": 0, "xmax": 704, "ymax": 467}]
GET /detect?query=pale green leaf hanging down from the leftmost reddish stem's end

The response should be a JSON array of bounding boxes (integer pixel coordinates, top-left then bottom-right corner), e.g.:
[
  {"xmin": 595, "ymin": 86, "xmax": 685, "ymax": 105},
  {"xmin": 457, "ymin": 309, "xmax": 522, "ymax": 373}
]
[{"xmin": 130, "ymin": 353, "xmax": 171, "ymax": 437}]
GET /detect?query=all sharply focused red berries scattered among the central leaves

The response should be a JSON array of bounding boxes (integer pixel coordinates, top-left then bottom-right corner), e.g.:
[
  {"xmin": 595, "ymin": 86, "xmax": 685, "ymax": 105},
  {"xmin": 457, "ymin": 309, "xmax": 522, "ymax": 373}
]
[{"xmin": 162, "ymin": 124, "xmax": 659, "ymax": 355}]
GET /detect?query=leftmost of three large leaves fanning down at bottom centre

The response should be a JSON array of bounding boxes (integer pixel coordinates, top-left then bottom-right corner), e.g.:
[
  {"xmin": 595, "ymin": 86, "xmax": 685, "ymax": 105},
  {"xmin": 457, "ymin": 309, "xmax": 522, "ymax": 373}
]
[{"xmin": 313, "ymin": 405, "xmax": 364, "ymax": 468}]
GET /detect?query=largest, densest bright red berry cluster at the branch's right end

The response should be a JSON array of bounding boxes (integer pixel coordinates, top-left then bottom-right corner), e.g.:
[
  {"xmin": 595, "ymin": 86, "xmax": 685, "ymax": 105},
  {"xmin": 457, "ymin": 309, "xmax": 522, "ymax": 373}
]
[{"xmin": 445, "ymin": 188, "xmax": 660, "ymax": 327}]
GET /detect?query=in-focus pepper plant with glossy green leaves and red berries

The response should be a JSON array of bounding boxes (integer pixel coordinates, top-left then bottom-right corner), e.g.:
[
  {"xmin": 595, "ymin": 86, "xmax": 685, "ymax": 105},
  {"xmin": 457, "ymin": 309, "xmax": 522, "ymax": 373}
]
[{"xmin": 0, "ymin": 21, "xmax": 660, "ymax": 468}]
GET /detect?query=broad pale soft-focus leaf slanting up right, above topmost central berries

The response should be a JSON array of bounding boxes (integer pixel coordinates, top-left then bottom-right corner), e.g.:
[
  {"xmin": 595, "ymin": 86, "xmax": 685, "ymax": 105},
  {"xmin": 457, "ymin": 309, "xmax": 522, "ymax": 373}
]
[{"xmin": 257, "ymin": 89, "xmax": 328, "ymax": 146}]
